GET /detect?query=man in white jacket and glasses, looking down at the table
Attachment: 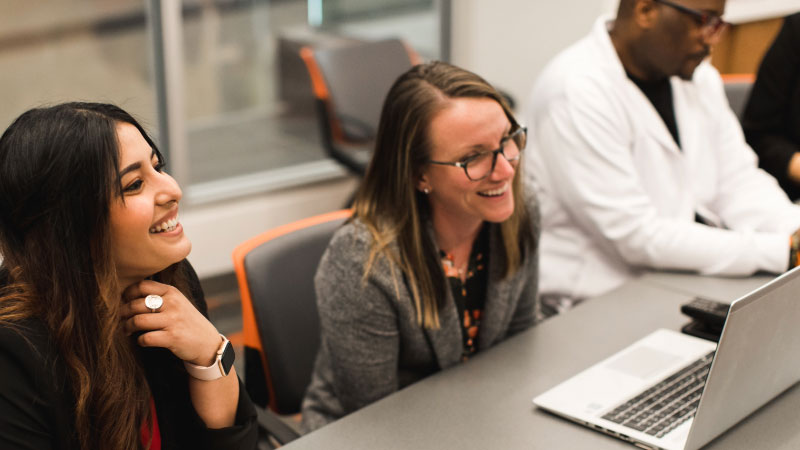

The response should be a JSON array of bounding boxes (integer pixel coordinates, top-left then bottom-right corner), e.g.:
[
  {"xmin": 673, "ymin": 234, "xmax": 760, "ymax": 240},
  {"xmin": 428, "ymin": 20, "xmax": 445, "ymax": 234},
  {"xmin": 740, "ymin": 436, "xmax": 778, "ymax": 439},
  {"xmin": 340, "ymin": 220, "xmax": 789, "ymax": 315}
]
[{"xmin": 524, "ymin": 0, "xmax": 800, "ymax": 312}]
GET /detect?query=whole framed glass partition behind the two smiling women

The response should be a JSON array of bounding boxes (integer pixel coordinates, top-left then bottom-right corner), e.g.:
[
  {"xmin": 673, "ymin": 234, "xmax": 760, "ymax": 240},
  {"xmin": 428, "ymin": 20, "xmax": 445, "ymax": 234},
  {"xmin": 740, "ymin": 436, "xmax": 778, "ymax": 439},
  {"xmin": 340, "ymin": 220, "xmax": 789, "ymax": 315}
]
[{"xmin": 0, "ymin": 0, "xmax": 446, "ymax": 204}]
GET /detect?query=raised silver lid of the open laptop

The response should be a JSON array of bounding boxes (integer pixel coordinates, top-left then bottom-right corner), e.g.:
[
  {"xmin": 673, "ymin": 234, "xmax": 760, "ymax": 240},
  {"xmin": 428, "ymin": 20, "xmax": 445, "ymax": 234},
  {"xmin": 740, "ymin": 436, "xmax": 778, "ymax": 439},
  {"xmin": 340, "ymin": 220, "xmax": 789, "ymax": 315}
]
[{"xmin": 685, "ymin": 268, "xmax": 800, "ymax": 450}]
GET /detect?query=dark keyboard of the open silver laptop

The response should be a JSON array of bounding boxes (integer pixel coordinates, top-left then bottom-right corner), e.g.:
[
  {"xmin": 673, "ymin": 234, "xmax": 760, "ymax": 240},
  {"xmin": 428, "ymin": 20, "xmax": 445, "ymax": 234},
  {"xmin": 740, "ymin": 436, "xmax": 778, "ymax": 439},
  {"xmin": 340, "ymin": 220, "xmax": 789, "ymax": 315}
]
[{"xmin": 603, "ymin": 352, "xmax": 714, "ymax": 438}]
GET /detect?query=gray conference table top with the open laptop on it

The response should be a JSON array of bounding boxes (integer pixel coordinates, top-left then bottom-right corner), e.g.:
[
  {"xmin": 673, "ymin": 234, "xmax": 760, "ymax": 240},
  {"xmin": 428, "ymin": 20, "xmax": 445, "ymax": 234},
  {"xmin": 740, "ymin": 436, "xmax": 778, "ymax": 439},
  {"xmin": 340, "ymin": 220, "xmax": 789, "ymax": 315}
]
[{"xmin": 285, "ymin": 274, "xmax": 800, "ymax": 450}]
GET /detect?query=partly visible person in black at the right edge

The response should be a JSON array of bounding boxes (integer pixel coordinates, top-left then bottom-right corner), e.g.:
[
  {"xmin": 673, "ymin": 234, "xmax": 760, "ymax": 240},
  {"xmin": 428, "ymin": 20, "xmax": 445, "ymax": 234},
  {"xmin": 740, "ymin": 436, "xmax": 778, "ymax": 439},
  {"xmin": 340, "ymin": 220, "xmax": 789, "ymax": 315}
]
[{"xmin": 742, "ymin": 13, "xmax": 800, "ymax": 201}]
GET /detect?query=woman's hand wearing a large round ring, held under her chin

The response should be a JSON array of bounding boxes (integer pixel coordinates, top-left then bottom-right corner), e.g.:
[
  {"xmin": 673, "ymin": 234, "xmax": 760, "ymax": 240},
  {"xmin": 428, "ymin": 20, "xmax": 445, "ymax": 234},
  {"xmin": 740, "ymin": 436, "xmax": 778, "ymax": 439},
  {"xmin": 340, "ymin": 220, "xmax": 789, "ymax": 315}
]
[{"xmin": 120, "ymin": 280, "xmax": 222, "ymax": 367}]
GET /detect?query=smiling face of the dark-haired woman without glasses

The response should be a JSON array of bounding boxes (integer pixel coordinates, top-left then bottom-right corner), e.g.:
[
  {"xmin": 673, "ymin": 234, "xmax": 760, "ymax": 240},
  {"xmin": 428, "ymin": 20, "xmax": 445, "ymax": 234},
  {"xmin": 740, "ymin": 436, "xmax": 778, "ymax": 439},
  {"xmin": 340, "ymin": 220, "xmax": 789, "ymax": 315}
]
[{"xmin": 109, "ymin": 123, "xmax": 192, "ymax": 286}]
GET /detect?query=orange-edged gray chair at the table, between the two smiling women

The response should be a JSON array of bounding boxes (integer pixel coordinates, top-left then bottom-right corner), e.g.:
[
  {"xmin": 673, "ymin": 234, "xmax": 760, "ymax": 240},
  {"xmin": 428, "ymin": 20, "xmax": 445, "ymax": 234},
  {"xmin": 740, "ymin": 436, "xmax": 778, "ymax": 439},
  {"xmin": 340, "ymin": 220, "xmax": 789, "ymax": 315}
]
[{"xmin": 233, "ymin": 210, "xmax": 352, "ymax": 444}]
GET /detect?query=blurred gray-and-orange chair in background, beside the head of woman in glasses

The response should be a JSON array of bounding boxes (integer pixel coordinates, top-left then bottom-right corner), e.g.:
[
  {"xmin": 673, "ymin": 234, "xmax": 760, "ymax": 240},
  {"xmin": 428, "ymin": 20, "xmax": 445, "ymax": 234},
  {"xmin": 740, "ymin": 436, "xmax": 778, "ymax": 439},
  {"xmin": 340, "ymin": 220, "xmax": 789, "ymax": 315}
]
[{"xmin": 300, "ymin": 39, "xmax": 419, "ymax": 176}]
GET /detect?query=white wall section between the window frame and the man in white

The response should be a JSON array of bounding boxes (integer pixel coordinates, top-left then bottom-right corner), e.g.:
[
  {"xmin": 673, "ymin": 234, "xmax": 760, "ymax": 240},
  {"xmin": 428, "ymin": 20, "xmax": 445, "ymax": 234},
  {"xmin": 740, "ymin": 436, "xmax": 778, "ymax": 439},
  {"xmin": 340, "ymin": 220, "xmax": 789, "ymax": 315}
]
[{"xmin": 451, "ymin": 0, "xmax": 618, "ymax": 107}]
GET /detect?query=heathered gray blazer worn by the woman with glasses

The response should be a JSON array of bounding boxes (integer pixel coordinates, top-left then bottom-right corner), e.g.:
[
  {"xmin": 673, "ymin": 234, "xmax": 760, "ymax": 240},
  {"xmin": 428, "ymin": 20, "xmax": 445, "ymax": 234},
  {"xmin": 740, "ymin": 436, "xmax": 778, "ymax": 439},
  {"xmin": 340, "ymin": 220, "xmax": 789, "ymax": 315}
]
[{"xmin": 302, "ymin": 195, "xmax": 540, "ymax": 431}]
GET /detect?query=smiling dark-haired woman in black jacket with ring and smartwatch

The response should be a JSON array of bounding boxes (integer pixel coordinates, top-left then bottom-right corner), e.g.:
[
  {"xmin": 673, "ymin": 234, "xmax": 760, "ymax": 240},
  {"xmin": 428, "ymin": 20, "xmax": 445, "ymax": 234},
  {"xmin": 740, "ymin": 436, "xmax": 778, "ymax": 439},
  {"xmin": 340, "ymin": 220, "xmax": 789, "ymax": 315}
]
[{"xmin": 0, "ymin": 103, "xmax": 257, "ymax": 450}]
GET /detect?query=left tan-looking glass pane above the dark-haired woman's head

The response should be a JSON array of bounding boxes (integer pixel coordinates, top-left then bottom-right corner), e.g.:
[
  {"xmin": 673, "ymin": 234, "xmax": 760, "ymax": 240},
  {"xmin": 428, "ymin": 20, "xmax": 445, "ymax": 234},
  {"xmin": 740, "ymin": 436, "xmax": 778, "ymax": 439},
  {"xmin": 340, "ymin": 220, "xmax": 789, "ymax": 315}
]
[{"xmin": 0, "ymin": 0, "xmax": 156, "ymax": 130}]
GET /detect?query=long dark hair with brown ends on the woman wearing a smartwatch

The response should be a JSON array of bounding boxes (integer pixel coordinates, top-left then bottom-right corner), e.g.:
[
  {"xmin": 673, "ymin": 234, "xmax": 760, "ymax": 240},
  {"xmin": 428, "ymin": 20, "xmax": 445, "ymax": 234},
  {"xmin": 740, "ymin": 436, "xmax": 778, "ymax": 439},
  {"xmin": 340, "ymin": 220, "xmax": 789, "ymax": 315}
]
[{"xmin": 0, "ymin": 103, "xmax": 185, "ymax": 449}]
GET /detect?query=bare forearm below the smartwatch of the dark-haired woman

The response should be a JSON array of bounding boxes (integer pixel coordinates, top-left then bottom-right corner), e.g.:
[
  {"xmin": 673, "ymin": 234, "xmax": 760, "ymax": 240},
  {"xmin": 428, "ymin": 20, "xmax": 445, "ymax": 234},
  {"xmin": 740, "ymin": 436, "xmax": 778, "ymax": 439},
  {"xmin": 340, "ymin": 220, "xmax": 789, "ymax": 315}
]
[{"xmin": 189, "ymin": 368, "xmax": 239, "ymax": 429}]
